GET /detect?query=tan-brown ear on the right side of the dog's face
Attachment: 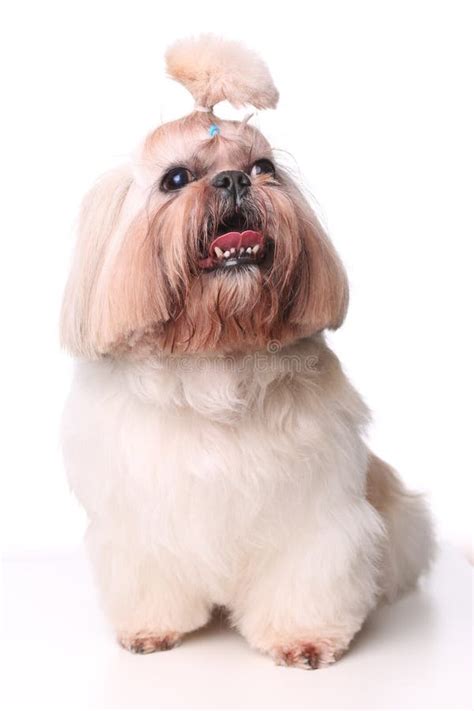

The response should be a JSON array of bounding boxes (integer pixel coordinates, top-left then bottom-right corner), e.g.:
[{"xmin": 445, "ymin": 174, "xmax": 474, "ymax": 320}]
[{"xmin": 291, "ymin": 210, "xmax": 349, "ymax": 333}]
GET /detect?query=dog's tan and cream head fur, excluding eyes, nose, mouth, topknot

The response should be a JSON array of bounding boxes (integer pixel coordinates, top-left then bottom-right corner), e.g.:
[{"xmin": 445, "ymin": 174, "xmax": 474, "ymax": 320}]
[{"xmin": 62, "ymin": 113, "xmax": 347, "ymax": 357}]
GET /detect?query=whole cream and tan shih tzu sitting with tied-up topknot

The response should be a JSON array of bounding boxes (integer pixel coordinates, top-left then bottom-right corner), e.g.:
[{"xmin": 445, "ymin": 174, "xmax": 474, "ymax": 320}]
[{"xmin": 62, "ymin": 36, "xmax": 433, "ymax": 669}]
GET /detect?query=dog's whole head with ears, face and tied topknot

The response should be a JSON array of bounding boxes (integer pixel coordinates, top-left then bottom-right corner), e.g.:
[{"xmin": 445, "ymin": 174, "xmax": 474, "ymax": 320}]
[{"xmin": 62, "ymin": 37, "xmax": 347, "ymax": 358}]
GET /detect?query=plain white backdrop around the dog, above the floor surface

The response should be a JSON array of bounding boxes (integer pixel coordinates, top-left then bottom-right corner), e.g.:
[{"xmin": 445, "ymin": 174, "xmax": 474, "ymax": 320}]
[{"xmin": 0, "ymin": 0, "xmax": 474, "ymax": 553}]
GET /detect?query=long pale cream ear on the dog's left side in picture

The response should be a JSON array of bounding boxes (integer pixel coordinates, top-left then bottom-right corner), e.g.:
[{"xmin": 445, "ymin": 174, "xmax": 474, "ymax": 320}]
[{"xmin": 61, "ymin": 169, "xmax": 132, "ymax": 358}]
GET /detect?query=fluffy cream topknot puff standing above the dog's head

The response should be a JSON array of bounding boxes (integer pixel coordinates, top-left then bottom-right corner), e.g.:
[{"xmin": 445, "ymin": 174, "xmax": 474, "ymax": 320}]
[{"xmin": 166, "ymin": 35, "xmax": 278, "ymax": 111}]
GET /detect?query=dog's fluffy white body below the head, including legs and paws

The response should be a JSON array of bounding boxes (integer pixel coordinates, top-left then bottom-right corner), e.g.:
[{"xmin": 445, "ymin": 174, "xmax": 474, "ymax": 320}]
[{"xmin": 63, "ymin": 336, "xmax": 432, "ymax": 667}]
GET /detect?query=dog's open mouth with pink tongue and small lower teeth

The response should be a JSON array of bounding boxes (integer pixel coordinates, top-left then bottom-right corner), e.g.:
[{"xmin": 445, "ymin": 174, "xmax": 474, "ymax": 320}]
[{"xmin": 198, "ymin": 218, "xmax": 266, "ymax": 270}]
